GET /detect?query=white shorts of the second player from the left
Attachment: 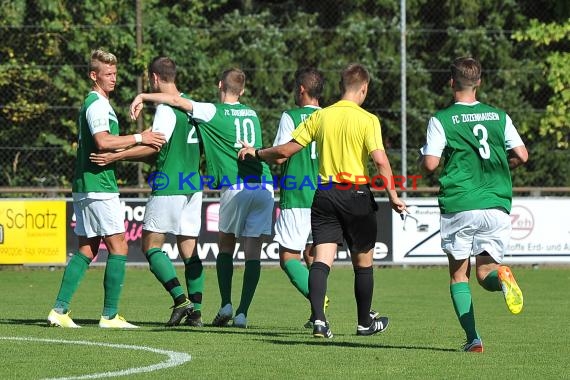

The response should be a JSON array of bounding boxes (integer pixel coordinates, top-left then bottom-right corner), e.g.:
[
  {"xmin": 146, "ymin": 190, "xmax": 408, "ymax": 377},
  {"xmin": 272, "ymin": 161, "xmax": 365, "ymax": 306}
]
[{"xmin": 143, "ymin": 192, "xmax": 202, "ymax": 237}]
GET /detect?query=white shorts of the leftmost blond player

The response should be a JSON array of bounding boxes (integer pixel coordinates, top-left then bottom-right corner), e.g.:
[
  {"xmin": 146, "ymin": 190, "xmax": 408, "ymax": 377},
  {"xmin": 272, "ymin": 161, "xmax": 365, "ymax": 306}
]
[{"xmin": 73, "ymin": 193, "xmax": 125, "ymax": 238}]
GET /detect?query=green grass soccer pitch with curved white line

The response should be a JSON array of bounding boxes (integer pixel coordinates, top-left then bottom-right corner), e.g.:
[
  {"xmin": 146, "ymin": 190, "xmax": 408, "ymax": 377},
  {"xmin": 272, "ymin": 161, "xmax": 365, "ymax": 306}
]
[{"xmin": 0, "ymin": 266, "xmax": 570, "ymax": 379}]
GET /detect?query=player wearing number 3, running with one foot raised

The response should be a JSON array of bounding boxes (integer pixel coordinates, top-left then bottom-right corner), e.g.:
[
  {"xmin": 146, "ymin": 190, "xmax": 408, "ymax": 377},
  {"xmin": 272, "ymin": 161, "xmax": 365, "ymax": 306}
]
[{"xmin": 414, "ymin": 57, "xmax": 528, "ymax": 352}]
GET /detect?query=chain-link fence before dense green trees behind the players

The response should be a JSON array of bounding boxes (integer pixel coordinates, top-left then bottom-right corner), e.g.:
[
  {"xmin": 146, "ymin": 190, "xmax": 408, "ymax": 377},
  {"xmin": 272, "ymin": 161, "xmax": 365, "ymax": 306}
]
[{"xmin": 0, "ymin": 0, "xmax": 570, "ymax": 194}]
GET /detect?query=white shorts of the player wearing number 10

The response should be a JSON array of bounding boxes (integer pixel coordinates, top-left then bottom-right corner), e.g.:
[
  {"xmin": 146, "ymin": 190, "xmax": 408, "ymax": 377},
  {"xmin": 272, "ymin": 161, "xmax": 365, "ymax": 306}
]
[{"xmin": 219, "ymin": 184, "xmax": 274, "ymax": 238}]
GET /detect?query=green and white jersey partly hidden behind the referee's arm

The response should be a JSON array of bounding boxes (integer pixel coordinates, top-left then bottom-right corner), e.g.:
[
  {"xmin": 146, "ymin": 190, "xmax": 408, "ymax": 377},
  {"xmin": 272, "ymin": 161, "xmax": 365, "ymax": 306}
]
[{"xmin": 273, "ymin": 106, "xmax": 320, "ymax": 209}]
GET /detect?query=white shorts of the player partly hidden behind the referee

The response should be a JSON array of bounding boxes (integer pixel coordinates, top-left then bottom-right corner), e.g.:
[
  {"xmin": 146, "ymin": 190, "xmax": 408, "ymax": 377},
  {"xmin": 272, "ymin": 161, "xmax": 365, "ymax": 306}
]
[{"xmin": 273, "ymin": 208, "xmax": 313, "ymax": 252}]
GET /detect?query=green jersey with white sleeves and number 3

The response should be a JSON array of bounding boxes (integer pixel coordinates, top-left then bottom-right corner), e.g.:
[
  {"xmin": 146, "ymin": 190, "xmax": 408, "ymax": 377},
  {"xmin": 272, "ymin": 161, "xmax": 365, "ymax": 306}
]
[{"xmin": 422, "ymin": 102, "xmax": 524, "ymax": 214}]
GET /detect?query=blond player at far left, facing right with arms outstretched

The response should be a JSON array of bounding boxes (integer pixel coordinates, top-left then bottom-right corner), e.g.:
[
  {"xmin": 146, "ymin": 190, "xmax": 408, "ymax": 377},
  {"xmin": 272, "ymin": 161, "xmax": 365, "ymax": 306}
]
[{"xmin": 48, "ymin": 49, "xmax": 164, "ymax": 328}]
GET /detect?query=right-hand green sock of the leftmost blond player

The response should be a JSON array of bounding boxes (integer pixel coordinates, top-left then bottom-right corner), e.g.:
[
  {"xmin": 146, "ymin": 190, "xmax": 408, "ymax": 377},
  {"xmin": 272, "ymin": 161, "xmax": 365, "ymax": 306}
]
[{"xmin": 101, "ymin": 253, "xmax": 127, "ymax": 319}]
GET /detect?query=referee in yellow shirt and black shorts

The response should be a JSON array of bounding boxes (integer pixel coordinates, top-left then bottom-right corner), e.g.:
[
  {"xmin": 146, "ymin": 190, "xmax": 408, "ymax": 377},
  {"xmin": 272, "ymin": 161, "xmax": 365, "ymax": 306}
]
[{"xmin": 239, "ymin": 63, "xmax": 406, "ymax": 338}]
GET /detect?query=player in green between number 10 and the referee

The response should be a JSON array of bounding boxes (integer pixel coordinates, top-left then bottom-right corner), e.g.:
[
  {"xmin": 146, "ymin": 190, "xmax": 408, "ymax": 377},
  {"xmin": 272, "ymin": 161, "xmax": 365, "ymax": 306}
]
[{"xmin": 273, "ymin": 67, "xmax": 327, "ymax": 328}]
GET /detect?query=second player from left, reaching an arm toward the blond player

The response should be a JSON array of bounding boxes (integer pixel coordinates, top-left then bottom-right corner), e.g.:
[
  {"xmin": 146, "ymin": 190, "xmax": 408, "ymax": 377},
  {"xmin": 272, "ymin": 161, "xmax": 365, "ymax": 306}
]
[{"xmin": 91, "ymin": 57, "xmax": 204, "ymax": 326}]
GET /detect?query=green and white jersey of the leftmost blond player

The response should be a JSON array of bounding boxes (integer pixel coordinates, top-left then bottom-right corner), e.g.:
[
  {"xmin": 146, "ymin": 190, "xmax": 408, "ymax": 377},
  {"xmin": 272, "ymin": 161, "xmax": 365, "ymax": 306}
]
[{"xmin": 72, "ymin": 91, "xmax": 119, "ymax": 199}]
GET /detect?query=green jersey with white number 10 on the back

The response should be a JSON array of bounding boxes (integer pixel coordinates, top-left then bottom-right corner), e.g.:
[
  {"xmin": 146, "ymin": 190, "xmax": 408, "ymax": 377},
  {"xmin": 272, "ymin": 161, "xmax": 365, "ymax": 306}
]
[{"xmin": 191, "ymin": 102, "xmax": 273, "ymax": 188}]
